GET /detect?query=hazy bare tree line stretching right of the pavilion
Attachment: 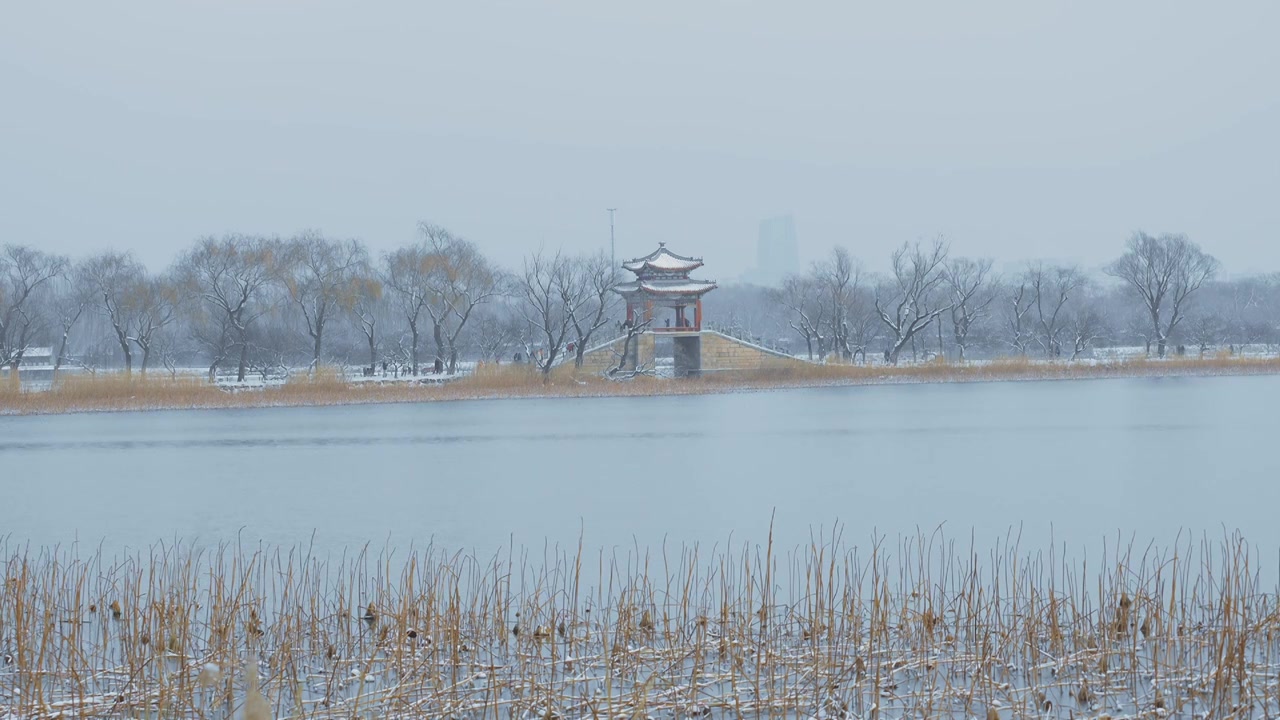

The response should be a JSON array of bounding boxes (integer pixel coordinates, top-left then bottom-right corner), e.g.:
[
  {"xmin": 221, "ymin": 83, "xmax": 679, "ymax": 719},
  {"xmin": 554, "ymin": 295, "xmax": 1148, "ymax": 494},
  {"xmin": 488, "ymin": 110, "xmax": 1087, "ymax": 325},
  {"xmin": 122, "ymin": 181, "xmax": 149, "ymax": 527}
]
[{"xmin": 714, "ymin": 232, "xmax": 1233, "ymax": 364}]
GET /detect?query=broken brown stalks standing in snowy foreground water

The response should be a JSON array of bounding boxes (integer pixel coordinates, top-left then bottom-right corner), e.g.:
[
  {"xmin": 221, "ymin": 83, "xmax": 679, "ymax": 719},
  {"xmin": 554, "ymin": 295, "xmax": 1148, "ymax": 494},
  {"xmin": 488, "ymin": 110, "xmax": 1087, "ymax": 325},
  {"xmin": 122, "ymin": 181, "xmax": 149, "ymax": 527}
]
[{"xmin": 0, "ymin": 533, "xmax": 1280, "ymax": 720}]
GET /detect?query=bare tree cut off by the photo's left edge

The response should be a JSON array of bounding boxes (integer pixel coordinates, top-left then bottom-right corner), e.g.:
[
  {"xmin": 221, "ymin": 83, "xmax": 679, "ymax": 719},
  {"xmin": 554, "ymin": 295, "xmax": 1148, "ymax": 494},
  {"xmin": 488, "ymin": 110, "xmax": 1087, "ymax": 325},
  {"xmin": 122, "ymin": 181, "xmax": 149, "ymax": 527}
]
[{"xmin": 0, "ymin": 245, "xmax": 68, "ymax": 366}]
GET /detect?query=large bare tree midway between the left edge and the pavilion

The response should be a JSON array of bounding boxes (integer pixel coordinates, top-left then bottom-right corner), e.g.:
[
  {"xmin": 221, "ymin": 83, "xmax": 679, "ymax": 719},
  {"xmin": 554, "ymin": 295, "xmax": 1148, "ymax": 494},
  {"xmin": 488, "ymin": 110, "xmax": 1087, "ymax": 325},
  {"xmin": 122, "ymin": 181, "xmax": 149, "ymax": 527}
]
[{"xmin": 279, "ymin": 231, "xmax": 367, "ymax": 369}]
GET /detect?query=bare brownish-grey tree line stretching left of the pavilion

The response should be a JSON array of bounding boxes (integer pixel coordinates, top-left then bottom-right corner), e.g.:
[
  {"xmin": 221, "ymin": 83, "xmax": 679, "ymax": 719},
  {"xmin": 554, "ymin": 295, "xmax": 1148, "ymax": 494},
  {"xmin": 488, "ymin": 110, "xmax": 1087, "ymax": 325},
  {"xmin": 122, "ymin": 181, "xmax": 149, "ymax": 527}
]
[{"xmin": 0, "ymin": 223, "xmax": 617, "ymax": 380}]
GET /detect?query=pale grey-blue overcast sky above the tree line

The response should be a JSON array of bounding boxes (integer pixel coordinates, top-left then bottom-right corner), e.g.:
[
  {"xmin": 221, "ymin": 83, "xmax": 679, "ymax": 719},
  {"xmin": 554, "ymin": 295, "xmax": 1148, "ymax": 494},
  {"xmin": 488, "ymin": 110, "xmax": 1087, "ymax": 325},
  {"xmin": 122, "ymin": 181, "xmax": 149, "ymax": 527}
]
[{"xmin": 0, "ymin": 0, "xmax": 1280, "ymax": 279}]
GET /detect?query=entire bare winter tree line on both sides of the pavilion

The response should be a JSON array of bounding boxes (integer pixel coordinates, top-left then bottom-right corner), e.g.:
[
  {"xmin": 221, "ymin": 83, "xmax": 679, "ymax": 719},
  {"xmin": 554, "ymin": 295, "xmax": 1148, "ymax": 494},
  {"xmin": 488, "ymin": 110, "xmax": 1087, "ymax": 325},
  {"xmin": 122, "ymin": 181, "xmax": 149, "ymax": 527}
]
[{"xmin": 0, "ymin": 223, "xmax": 1259, "ymax": 380}]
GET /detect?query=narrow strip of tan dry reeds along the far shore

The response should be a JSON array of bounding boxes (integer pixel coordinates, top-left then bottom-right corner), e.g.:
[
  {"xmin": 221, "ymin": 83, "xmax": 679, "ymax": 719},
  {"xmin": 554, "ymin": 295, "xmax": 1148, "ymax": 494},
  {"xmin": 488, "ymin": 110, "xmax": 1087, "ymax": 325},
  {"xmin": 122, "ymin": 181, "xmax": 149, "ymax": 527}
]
[{"xmin": 0, "ymin": 356, "xmax": 1280, "ymax": 415}]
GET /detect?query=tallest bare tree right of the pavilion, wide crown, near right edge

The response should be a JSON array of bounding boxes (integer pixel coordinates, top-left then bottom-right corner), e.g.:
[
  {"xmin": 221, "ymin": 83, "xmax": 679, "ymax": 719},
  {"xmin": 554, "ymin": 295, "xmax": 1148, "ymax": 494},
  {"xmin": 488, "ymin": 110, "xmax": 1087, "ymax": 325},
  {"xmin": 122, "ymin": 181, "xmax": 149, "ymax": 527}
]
[{"xmin": 1107, "ymin": 232, "xmax": 1219, "ymax": 357}]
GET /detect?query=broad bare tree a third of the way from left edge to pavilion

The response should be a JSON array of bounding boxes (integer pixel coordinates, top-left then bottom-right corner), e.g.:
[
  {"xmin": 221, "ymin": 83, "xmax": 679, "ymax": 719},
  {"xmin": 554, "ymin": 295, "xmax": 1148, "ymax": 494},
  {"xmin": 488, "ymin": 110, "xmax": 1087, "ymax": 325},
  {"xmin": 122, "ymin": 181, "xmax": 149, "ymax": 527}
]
[{"xmin": 178, "ymin": 234, "xmax": 282, "ymax": 382}]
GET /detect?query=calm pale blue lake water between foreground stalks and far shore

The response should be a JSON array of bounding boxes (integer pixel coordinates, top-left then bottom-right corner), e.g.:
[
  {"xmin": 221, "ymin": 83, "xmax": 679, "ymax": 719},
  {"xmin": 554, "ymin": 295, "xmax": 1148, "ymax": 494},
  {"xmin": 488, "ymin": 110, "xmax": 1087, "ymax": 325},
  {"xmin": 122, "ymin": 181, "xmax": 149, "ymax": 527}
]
[{"xmin": 0, "ymin": 377, "xmax": 1280, "ymax": 566}]
